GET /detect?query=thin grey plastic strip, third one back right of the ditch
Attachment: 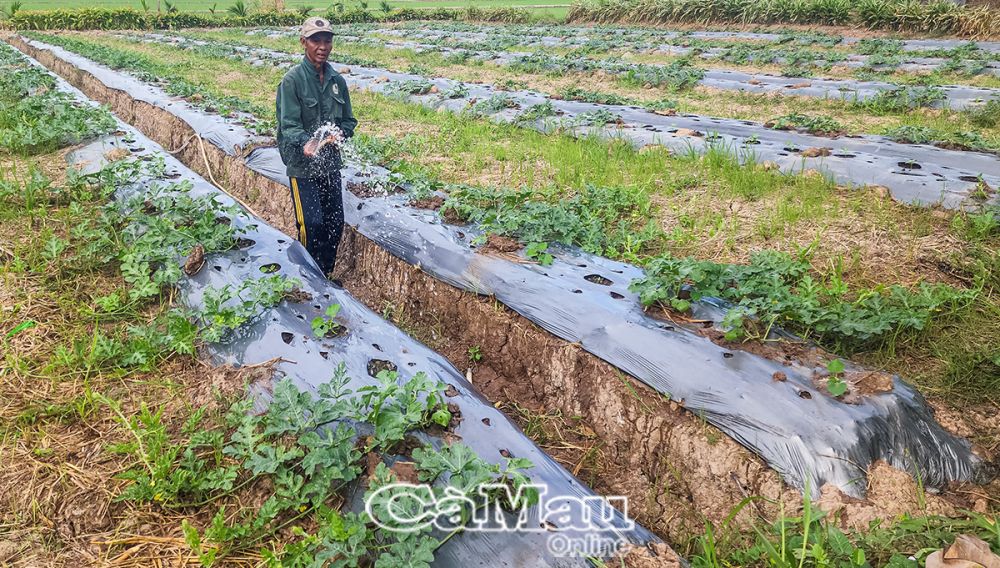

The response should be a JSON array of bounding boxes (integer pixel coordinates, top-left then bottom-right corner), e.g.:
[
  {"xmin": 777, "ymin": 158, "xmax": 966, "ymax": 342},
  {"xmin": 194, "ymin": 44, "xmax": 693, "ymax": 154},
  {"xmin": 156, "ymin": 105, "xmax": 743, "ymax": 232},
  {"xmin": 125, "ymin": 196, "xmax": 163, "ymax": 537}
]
[{"xmin": 211, "ymin": 28, "xmax": 1000, "ymax": 110}]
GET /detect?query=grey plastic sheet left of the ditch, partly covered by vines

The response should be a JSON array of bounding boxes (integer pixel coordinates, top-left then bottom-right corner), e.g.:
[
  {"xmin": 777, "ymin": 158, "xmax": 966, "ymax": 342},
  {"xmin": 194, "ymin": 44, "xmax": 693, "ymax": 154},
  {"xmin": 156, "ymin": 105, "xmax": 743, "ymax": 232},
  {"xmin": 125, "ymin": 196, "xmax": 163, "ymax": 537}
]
[{"xmin": 17, "ymin": 45, "xmax": 660, "ymax": 568}]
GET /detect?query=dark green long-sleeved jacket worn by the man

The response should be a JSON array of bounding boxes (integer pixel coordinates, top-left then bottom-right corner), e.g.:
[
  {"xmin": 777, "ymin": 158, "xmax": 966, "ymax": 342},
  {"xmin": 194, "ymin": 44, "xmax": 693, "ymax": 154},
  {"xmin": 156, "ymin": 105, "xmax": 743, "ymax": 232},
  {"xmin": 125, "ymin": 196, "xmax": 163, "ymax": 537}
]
[{"xmin": 275, "ymin": 57, "xmax": 358, "ymax": 177}]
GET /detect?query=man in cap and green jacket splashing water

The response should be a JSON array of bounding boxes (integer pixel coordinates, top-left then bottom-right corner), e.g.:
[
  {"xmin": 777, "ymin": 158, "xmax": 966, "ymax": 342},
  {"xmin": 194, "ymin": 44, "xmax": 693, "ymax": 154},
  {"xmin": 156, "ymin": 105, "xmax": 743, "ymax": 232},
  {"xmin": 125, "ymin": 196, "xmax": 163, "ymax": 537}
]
[{"xmin": 276, "ymin": 18, "xmax": 358, "ymax": 275}]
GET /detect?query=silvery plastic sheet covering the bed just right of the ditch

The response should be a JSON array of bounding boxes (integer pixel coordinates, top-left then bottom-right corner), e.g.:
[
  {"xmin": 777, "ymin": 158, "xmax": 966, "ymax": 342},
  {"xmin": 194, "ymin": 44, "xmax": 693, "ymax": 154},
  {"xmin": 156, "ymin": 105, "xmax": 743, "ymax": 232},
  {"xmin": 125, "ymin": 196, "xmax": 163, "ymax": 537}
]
[{"xmin": 17, "ymin": 36, "xmax": 980, "ymax": 496}]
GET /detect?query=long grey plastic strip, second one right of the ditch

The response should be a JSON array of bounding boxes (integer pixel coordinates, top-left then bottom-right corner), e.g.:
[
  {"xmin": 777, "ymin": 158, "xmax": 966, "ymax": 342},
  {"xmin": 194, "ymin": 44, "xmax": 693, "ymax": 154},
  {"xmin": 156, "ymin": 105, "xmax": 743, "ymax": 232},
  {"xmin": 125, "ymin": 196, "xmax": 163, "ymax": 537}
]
[{"xmin": 107, "ymin": 31, "xmax": 1000, "ymax": 209}]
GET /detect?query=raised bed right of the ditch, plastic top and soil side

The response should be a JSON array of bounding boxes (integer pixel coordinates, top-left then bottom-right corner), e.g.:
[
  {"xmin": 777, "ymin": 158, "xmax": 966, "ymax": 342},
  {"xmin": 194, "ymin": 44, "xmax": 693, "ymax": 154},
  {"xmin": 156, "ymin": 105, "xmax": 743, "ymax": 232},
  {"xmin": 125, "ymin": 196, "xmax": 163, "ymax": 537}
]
[{"xmin": 8, "ymin": 37, "xmax": 992, "ymax": 539}]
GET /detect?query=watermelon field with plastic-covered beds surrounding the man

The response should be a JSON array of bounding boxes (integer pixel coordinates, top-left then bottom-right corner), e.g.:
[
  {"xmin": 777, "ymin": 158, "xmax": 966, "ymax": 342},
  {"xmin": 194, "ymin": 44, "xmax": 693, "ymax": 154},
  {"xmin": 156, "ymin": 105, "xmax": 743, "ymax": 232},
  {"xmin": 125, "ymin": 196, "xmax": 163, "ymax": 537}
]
[{"xmin": 0, "ymin": 7, "xmax": 1000, "ymax": 567}]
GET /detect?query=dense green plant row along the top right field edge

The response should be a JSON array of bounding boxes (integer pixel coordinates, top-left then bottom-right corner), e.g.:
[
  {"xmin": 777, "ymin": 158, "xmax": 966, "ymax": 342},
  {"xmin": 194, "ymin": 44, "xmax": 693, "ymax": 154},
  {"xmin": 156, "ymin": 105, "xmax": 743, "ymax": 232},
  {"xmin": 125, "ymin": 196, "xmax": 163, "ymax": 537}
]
[{"xmin": 567, "ymin": 0, "xmax": 1000, "ymax": 37}]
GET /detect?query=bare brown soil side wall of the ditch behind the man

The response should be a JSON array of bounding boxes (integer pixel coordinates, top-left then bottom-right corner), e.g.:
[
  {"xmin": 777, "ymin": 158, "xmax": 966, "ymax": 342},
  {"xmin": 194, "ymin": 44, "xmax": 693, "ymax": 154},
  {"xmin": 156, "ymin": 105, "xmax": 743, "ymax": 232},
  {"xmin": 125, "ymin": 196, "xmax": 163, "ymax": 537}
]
[{"xmin": 11, "ymin": 33, "xmax": 992, "ymax": 542}]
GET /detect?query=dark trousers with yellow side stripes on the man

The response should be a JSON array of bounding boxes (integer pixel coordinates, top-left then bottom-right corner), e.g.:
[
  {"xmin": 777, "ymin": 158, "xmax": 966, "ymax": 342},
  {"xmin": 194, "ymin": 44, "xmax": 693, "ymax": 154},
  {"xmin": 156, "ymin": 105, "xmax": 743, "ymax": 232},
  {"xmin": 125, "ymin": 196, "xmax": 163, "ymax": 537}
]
[{"xmin": 289, "ymin": 170, "xmax": 344, "ymax": 275}]
